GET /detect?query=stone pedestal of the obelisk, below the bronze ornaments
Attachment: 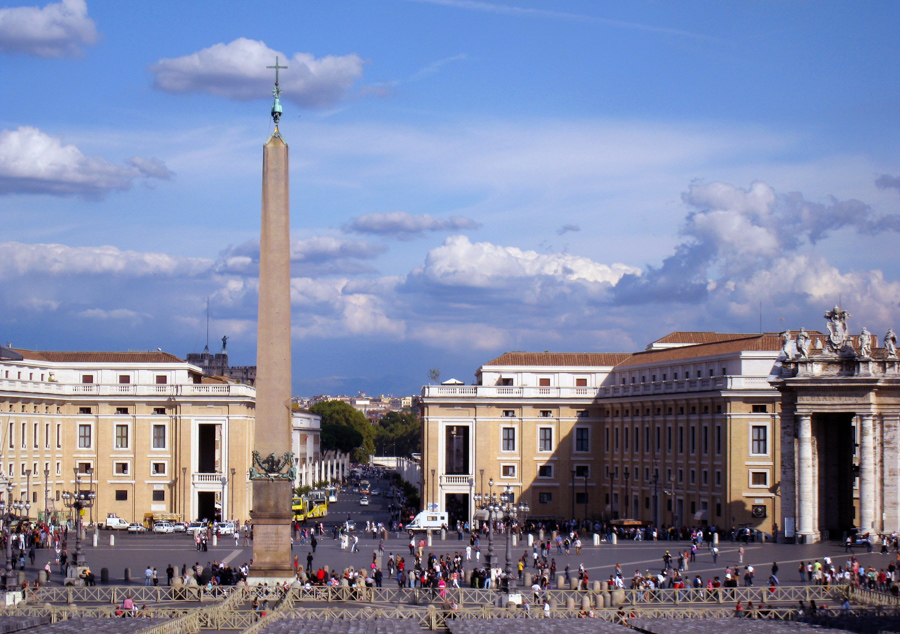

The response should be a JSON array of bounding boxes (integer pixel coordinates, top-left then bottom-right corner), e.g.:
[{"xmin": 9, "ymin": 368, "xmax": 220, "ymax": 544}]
[{"xmin": 247, "ymin": 480, "xmax": 295, "ymax": 585}]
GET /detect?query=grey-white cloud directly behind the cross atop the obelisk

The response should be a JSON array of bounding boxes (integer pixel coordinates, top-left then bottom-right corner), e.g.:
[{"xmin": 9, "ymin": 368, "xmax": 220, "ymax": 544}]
[{"xmin": 150, "ymin": 37, "xmax": 364, "ymax": 108}]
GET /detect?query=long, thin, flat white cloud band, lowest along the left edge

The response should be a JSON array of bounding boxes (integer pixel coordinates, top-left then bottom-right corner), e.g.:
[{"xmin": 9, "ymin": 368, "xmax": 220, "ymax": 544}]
[{"xmin": 0, "ymin": 242, "xmax": 212, "ymax": 278}]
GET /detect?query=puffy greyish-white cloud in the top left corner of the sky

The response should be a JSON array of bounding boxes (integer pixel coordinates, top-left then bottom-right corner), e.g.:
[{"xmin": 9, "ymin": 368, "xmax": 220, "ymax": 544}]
[{"xmin": 0, "ymin": 0, "xmax": 97, "ymax": 57}]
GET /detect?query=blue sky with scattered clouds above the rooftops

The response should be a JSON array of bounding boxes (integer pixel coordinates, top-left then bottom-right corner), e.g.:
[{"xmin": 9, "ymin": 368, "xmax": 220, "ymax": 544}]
[{"xmin": 0, "ymin": 0, "xmax": 900, "ymax": 395}]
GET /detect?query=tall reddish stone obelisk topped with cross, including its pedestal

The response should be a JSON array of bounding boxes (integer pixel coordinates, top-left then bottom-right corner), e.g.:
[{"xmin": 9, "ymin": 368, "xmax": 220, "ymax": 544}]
[{"xmin": 248, "ymin": 58, "xmax": 294, "ymax": 584}]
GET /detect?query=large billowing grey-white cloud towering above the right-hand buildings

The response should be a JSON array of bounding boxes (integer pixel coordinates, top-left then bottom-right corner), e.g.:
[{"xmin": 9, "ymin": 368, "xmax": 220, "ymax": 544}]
[{"xmin": 615, "ymin": 182, "xmax": 900, "ymax": 303}]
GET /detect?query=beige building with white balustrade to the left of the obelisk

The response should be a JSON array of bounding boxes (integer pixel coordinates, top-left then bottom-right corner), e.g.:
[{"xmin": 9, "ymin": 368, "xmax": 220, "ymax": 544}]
[{"xmin": 0, "ymin": 348, "xmax": 255, "ymax": 522}]
